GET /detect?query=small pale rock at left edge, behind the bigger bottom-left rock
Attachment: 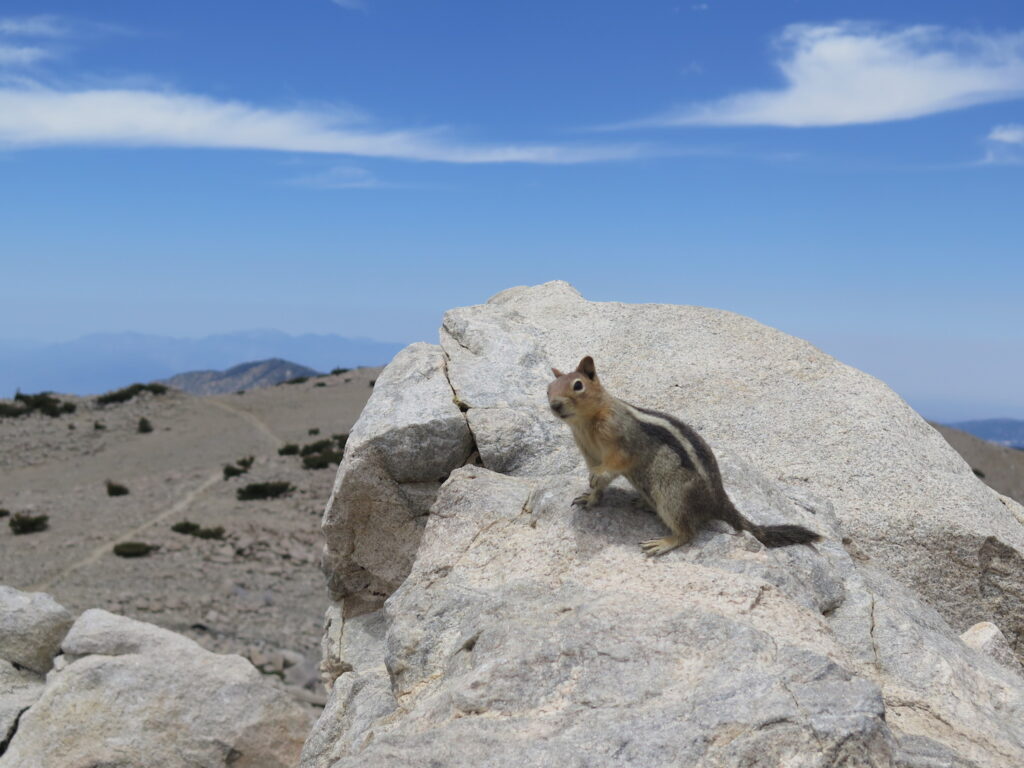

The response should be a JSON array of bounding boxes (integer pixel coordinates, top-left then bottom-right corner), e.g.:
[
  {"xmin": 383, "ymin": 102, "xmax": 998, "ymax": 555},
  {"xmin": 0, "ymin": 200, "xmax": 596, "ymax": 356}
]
[{"xmin": 0, "ymin": 586, "xmax": 74, "ymax": 674}]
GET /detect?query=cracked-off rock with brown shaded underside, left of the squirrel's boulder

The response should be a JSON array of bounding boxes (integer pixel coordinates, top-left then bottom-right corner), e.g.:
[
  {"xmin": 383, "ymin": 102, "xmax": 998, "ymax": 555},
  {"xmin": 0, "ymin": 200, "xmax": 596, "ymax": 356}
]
[{"xmin": 323, "ymin": 344, "xmax": 473, "ymax": 612}]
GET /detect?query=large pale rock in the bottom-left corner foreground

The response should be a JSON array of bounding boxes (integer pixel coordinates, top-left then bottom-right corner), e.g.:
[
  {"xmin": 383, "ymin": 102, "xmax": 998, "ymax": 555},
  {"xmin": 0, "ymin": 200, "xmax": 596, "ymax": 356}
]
[{"xmin": 0, "ymin": 610, "xmax": 309, "ymax": 768}]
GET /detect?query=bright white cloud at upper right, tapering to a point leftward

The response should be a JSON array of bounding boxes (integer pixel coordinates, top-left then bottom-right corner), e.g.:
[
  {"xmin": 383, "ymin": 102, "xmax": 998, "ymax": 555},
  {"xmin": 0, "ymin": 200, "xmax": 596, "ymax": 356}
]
[{"xmin": 613, "ymin": 22, "xmax": 1024, "ymax": 128}]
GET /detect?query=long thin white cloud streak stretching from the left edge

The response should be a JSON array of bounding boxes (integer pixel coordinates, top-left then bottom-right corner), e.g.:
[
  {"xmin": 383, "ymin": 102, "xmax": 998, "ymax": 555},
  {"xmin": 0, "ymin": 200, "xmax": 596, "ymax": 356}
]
[{"xmin": 0, "ymin": 82, "xmax": 645, "ymax": 164}]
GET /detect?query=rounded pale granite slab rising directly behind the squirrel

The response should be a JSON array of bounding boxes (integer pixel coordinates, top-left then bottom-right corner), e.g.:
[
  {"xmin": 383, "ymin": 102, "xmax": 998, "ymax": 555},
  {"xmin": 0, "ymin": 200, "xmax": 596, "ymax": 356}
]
[{"xmin": 441, "ymin": 283, "xmax": 1024, "ymax": 647}]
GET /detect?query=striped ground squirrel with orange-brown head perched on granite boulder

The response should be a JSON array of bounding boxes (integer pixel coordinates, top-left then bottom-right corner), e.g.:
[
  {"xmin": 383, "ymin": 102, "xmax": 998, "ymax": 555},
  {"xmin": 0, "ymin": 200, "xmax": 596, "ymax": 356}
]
[{"xmin": 548, "ymin": 356, "xmax": 821, "ymax": 555}]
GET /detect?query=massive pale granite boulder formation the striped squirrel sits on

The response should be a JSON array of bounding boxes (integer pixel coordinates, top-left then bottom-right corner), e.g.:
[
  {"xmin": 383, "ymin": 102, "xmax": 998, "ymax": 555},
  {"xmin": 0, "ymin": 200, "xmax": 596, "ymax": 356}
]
[{"xmin": 302, "ymin": 283, "xmax": 1024, "ymax": 768}]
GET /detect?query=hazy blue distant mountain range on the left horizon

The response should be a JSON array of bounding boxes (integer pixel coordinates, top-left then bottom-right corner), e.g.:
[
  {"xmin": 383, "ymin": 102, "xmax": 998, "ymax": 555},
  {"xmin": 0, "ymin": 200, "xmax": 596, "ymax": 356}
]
[{"xmin": 0, "ymin": 331, "xmax": 403, "ymax": 397}]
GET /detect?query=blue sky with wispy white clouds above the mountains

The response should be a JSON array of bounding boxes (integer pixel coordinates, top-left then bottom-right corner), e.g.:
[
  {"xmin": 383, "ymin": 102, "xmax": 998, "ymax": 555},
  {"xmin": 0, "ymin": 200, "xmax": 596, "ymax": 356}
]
[{"xmin": 0, "ymin": 0, "xmax": 1024, "ymax": 420}]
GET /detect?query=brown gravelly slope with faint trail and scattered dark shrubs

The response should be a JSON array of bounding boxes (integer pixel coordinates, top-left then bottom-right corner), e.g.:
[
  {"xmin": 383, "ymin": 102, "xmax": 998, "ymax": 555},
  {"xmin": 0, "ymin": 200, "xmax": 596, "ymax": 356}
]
[{"xmin": 0, "ymin": 369, "xmax": 378, "ymax": 700}]
